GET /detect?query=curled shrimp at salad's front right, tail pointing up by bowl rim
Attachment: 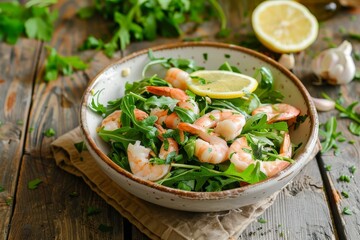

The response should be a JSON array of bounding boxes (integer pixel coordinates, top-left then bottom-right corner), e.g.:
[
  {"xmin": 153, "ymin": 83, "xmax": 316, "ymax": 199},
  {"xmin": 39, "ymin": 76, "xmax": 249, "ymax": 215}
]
[{"xmin": 228, "ymin": 133, "xmax": 292, "ymax": 177}]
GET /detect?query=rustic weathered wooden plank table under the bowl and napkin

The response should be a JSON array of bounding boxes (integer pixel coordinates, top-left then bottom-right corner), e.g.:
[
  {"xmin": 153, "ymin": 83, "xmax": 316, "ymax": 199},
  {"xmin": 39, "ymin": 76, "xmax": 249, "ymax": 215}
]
[{"xmin": 0, "ymin": 0, "xmax": 360, "ymax": 239}]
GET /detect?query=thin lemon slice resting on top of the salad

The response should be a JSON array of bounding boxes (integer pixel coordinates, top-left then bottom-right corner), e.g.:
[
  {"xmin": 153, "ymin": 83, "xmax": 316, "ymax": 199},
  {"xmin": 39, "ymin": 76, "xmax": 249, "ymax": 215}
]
[{"xmin": 187, "ymin": 70, "xmax": 258, "ymax": 99}]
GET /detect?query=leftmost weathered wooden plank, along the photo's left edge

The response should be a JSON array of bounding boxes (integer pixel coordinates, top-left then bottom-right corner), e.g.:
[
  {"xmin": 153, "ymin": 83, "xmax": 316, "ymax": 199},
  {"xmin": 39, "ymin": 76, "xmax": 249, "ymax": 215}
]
[{"xmin": 0, "ymin": 39, "xmax": 41, "ymax": 238}]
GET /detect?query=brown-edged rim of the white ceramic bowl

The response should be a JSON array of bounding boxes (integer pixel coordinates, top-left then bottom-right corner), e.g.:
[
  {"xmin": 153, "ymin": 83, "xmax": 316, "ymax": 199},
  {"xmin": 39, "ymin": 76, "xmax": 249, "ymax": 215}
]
[{"xmin": 80, "ymin": 41, "xmax": 319, "ymax": 200}]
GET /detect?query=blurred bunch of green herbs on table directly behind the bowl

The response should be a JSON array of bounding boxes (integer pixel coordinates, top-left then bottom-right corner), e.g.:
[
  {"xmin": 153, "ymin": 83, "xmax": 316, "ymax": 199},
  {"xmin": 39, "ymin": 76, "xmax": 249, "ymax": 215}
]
[{"xmin": 78, "ymin": 0, "xmax": 227, "ymax": 54}]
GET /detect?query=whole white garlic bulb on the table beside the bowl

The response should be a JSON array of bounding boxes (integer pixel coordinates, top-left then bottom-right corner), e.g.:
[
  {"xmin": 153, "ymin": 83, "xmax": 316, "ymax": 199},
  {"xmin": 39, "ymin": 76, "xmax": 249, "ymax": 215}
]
[{"xmin": 311, "ymin": 41, "xmax": 356, "ymax": 85}]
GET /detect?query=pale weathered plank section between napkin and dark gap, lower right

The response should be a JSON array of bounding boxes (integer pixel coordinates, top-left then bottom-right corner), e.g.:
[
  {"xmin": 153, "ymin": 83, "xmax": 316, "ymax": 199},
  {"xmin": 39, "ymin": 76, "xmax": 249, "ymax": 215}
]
[{"xmin": 239, "ymin": 159, "xmax": 336, "ymax": 240}]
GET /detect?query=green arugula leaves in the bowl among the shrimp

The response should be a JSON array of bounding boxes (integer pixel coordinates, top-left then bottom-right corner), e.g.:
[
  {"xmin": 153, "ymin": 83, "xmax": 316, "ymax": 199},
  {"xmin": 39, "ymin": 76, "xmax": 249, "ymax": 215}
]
[{"xmin": 89, "ymin": 51, "xmax": 300, "ymax": 192}]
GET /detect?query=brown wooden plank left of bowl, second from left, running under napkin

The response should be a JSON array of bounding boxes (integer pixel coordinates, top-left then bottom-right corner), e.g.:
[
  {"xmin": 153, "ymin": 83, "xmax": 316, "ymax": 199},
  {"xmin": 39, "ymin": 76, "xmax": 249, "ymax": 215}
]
[{"xmin": 9, "ymin": 0, "xmax": 124, "ymax": 239}]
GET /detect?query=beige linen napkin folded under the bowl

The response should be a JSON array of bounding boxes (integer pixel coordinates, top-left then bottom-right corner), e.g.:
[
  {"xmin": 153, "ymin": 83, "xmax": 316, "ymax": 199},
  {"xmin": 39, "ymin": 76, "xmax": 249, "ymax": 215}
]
[{"xmin": 52, "ymin": 127, "xmax": 277, "ymax": 240}]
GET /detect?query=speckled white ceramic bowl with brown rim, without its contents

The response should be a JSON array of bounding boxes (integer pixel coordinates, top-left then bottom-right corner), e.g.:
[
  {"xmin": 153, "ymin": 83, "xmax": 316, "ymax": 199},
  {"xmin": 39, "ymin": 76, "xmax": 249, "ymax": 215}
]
[{"xmin": 80, "ymin": 42, "xmax": 318, "ymax": 212}]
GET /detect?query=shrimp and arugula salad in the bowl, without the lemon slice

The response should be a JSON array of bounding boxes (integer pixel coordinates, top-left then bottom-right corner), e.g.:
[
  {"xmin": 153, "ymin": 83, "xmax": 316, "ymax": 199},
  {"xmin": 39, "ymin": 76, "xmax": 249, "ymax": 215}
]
[{"xmin": 89, "ymin": 52, "xmax": 306, "ymax": 192}]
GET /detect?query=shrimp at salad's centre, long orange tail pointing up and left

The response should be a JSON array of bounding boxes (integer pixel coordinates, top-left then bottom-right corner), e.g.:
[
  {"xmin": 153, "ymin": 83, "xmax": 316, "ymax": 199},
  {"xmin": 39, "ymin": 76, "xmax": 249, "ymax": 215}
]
[{"xmin": 178, "ymin": 122, "xmax": 228, "ymax": 164}]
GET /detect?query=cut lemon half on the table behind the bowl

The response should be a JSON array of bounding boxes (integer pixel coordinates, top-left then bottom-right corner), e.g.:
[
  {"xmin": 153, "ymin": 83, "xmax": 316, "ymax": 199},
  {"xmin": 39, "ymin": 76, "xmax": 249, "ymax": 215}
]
[{"xmin": 251, "ymin": 0, "xmax": 319, "ymax": 53}]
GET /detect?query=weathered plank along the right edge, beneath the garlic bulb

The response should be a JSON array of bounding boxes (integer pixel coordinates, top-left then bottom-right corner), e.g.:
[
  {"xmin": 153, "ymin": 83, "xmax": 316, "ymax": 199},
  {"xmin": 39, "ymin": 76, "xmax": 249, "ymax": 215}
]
[{"xmin": 295, "ymin": 10, "xmax": 360, "ymax": 239}]
